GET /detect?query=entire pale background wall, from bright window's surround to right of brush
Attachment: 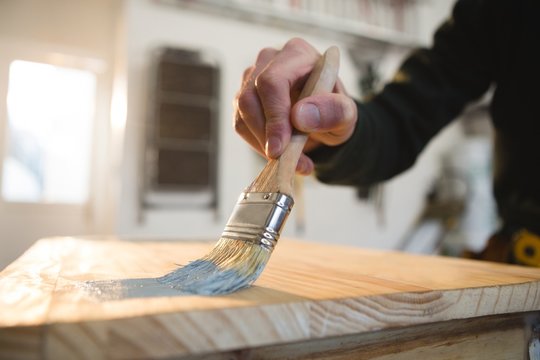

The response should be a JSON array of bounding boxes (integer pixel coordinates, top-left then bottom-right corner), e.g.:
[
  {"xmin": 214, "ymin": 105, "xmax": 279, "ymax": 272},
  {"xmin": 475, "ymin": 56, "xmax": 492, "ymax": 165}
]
[{"xmin": 0, "ymin": 0, "xmax": 459, "ymax": 268}]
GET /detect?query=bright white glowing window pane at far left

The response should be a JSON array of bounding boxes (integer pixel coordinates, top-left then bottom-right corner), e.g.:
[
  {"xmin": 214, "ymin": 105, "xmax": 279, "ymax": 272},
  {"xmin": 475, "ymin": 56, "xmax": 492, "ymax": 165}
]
[{"xmin": 2, "ymin": 60, "xmax": 96, "ymax": 204}]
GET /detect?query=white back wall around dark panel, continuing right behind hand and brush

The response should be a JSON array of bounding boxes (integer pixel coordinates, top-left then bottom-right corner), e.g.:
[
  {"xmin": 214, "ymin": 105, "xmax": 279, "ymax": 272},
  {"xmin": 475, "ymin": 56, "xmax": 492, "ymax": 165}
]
[{"xmin": 118, "ymin": 1, "xmax": 459, "ymax": 248}]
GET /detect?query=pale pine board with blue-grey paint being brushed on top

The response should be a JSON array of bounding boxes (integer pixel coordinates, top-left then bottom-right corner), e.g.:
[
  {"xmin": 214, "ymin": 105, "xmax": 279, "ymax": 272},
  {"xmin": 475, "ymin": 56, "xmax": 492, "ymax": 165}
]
[{"xmin": 0, "ymin": 238, "xmax": 540, "ymax": 359}]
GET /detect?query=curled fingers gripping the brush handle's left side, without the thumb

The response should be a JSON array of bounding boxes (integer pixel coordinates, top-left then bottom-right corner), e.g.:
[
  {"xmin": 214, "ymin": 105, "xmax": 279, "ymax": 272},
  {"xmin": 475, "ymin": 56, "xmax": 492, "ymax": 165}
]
[{"xmin": 235, "ymin": 39, "xmax": 320, "ymax": 158}]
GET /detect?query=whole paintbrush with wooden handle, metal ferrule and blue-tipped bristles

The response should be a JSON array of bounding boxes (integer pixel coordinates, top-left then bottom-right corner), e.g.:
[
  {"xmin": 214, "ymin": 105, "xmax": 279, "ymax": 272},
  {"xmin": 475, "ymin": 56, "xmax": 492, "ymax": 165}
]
[{"xmin": 158, "ymin": 46, "xmax": 339, "ymax": 295}]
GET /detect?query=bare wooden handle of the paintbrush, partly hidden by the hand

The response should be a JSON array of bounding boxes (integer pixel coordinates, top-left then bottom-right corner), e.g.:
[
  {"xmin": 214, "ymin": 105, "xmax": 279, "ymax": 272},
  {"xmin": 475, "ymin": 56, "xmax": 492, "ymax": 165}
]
[{"xmin": 246, "ymin": 46, "xmax": 339, "ymax": 195}]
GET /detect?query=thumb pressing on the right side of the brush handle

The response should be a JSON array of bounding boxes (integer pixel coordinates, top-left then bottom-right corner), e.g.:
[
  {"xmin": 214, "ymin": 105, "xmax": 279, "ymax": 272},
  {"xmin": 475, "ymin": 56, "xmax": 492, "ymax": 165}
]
[{"xmin": 291, "ymin": 93, "xmax": 357, "ymax": 151}]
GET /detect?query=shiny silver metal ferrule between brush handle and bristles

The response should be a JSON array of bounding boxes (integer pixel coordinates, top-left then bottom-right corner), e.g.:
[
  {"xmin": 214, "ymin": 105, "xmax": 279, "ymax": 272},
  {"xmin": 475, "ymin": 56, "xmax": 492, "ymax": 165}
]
[{"xmin": 221, "ymin": 193, "xmax": 294, "ymax": 252}]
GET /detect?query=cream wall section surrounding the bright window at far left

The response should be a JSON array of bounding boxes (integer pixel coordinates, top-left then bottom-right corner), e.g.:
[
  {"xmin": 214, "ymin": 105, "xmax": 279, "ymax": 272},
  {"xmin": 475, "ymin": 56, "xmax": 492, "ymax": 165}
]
[{"xmin": 0, "ymin": 0, "xmax": 117, "ymax": 269}]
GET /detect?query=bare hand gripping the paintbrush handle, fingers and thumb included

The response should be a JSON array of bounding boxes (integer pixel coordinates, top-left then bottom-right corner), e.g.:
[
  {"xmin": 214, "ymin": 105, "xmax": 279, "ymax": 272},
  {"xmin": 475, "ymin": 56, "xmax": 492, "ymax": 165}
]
[{"xmin": 234, "ymin": 38, "xmax": 357, "ymax": 175}]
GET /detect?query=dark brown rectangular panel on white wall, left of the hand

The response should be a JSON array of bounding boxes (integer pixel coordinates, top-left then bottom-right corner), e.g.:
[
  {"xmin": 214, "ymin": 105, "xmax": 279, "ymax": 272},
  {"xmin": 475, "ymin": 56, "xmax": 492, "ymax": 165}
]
[{"xmin": 144, "ymin": 48, "xmax": 219, "ymax": 207}]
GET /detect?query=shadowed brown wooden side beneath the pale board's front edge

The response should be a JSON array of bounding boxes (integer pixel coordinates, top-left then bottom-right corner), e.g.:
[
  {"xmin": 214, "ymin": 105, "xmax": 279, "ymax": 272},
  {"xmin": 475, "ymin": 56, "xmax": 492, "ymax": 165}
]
[{"xmin": 183, "ymin": 313, "xmax": 538, "ymax": 360}]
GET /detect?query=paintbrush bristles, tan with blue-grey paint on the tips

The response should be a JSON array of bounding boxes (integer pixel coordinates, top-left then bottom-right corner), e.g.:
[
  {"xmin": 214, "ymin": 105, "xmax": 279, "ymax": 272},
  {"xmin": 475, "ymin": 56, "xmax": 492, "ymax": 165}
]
[{"xmin": 158, "ymin": 238, "xmax": 271, "ymax": 295}]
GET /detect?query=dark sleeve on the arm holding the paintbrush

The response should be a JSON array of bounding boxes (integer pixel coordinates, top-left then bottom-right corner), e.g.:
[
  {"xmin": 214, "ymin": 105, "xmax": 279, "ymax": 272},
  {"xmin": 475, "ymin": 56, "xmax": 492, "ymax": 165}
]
[{"xmin": 308, "ymin": 0, "xmax": 494, "ymax": 186}]
